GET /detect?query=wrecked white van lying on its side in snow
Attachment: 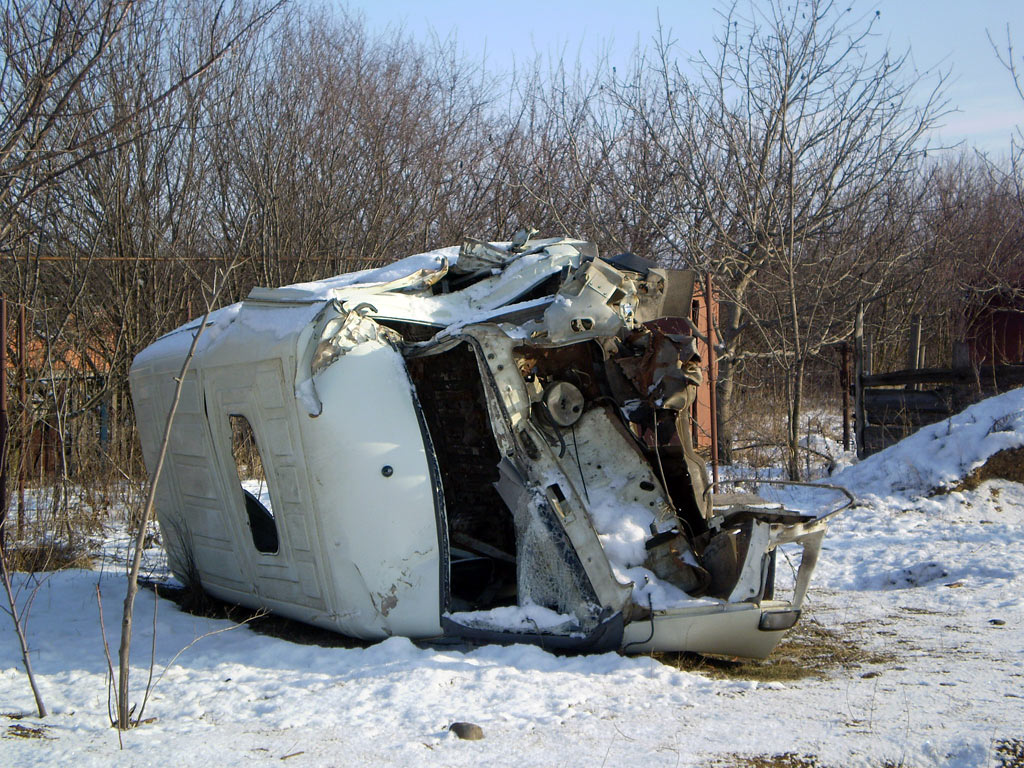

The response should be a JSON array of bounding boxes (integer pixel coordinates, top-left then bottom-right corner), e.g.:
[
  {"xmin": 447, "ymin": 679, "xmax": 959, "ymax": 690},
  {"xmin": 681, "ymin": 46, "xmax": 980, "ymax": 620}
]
[{"xmin": 131, "ymin": 237, "xmax": 847, "ymax": 657}]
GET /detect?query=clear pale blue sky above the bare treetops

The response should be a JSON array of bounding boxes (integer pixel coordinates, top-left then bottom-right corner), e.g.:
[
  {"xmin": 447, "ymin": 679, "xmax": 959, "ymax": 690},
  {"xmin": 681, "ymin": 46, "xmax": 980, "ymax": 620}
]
[{"xmin": 347, "ymin": 0, "xmax": 1024, "ymax": 154}]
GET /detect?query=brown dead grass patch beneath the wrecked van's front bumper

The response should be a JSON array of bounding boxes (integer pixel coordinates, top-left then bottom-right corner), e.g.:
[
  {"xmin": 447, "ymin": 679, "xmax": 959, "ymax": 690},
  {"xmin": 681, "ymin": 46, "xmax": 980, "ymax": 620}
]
[{"xmin": 654, "ymin": 616, "xmax": 895, "ymax": 684}]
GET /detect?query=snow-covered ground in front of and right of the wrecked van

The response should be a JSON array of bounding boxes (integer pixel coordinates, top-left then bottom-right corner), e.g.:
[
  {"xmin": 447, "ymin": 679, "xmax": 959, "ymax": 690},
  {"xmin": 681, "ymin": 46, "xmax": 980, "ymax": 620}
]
[{"xmin": 0, "ymin": 390, "xmax": 1024, "ymax": 768}]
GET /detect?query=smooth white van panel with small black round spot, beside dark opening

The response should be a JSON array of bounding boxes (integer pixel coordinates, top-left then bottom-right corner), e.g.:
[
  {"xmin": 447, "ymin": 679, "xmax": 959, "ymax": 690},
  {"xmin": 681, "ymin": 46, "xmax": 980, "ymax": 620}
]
[{"xmin": 299, "ymin": 343, "xmax": 441, "ymax": 637}]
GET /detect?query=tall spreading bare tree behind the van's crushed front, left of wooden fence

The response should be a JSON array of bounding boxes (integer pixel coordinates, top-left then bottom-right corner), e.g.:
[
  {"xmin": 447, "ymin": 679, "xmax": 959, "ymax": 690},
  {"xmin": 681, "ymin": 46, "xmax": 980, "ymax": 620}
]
[{"xmin": 606, "ymin": 0, "xmax": 944, "ymax": 478}]
